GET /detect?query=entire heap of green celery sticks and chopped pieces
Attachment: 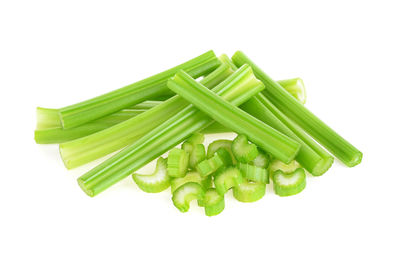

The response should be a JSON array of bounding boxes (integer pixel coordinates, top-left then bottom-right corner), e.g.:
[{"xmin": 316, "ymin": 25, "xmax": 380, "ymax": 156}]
[{"xmin": 35, "ymin": 51, "xmax": 362, "ymax": 216}]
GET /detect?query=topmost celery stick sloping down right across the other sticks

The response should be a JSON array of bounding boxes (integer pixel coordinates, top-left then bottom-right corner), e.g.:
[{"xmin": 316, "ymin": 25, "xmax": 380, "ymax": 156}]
[{"xmin": 168, "ymin": 71, "xmax": 300, "ymax": 162}]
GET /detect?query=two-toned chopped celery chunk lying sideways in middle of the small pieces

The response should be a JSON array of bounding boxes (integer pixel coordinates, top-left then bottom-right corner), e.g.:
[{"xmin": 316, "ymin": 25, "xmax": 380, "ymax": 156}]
[{"xmin": 196, "ymin": 148, "xmax": 232, "ymax": 177}]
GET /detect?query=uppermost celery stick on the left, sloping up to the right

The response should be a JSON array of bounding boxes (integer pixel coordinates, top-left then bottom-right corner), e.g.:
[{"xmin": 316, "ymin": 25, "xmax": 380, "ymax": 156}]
[{"xmin": 59, "ymin": 51, "xmax": 220, "ymax": 129}]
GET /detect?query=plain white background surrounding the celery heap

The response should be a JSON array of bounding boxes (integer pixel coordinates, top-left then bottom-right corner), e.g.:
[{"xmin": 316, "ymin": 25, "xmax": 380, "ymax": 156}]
[{"xmin": 0, "ymin": 0, "xmax": 400, "ymax": 259}]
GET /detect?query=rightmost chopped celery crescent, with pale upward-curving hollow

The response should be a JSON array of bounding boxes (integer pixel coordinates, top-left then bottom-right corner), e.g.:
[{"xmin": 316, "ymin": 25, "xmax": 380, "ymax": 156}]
[{"xmin": 272, "ymin": 168, "xmax": 306, "ymax": 196}]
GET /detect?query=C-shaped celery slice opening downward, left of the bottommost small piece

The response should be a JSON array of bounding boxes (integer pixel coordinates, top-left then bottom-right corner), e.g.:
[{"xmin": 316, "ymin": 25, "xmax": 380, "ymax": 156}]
[{"xmin": 172, "ymin": 182, "xmax": 205, "ymax": 212}]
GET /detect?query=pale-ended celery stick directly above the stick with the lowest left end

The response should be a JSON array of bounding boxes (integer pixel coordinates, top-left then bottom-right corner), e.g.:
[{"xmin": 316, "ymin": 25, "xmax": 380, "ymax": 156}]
[{"xmin": 60, "ymin": 65, "xmax": 233, "ymax": 169}]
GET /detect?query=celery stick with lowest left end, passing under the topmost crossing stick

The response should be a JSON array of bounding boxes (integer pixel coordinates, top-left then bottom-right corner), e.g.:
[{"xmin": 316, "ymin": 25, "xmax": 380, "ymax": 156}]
[{"xmin": 78, "ymin": 65, "xmax": 263, "ymax": 196}]
